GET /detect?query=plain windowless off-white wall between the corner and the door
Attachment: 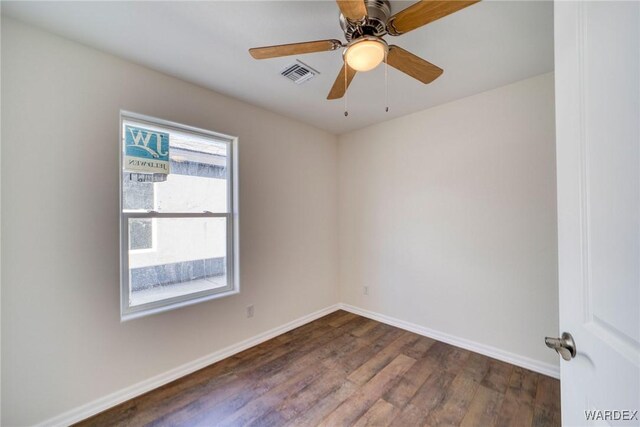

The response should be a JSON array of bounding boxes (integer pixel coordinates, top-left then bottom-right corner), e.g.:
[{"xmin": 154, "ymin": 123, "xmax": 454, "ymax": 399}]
[{"xmin": 338, "ymin": 74, "xmax": 558, "ymax": 366}]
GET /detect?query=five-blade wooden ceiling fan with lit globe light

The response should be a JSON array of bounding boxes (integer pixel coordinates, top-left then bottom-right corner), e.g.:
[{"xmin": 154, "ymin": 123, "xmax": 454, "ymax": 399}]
[{"xmin": 249, "ymin": 0, "xmax": 480, "ymax": 99}]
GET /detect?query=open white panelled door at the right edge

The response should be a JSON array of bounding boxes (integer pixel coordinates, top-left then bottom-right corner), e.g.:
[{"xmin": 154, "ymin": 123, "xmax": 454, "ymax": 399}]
[{"xmin": 555, "ymin": 1, "xmax": 640, "ymax": 426}]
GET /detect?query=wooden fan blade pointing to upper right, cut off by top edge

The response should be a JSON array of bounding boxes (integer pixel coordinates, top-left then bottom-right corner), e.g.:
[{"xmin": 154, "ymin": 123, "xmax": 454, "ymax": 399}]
[{"xmin": 387, "ymin": 0, "xmax": 480, "ymax": 36}]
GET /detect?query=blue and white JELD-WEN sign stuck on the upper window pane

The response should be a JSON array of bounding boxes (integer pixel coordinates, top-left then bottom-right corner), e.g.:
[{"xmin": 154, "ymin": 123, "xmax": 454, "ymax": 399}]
[{"xmin": 124, "ymin": 125, "xmax": 169, "ymax": 174}]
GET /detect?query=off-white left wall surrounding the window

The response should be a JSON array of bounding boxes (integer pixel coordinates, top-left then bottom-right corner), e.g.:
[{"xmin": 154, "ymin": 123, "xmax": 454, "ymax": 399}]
[{"xmin": 1, "ymin": 18, "xmax": 338, "ymax": 426}]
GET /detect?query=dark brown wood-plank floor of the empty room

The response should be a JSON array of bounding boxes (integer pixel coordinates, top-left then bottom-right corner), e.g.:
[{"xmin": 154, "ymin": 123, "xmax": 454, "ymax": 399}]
[{"xmin": 79, "ymin": 311, "xmax": 560, "ymax": 427}]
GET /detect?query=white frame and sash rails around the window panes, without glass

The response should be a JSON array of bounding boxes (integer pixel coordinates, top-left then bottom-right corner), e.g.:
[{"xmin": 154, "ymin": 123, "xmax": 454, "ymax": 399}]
[{"xmin": 118, "ymin": 110, "xmax": 240, "ymax": 321}]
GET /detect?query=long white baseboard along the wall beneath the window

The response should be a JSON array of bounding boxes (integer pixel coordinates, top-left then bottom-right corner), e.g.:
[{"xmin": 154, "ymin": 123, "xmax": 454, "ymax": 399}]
[{"xmin": 38, "ymin": 304, "xmax": 340, "ymax": 427}]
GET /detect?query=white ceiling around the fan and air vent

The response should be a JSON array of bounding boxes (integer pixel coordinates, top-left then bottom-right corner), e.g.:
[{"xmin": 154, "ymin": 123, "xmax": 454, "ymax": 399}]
[{"xmin": 2, "ymin": 0, "xmax": 553, "ymax": 134}]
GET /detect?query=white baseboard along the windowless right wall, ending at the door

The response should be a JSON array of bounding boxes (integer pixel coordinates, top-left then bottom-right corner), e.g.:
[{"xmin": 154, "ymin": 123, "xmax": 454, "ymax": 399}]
[{"xmin": 338, "ymin": 303, "xmax": 560, "ymax": 378}]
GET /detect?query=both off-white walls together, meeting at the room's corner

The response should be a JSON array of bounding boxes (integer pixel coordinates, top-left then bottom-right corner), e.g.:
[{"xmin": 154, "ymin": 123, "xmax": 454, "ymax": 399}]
[{"xmin": 0, "ymin": 18, "xmax": 558, "ymax": 425}]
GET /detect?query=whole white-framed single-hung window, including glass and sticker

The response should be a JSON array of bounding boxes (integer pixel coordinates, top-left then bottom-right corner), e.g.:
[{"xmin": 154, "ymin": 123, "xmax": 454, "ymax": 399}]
[{"xmin": 120, "ymin": 112, "xmax": 239, "ymax": 320}]
